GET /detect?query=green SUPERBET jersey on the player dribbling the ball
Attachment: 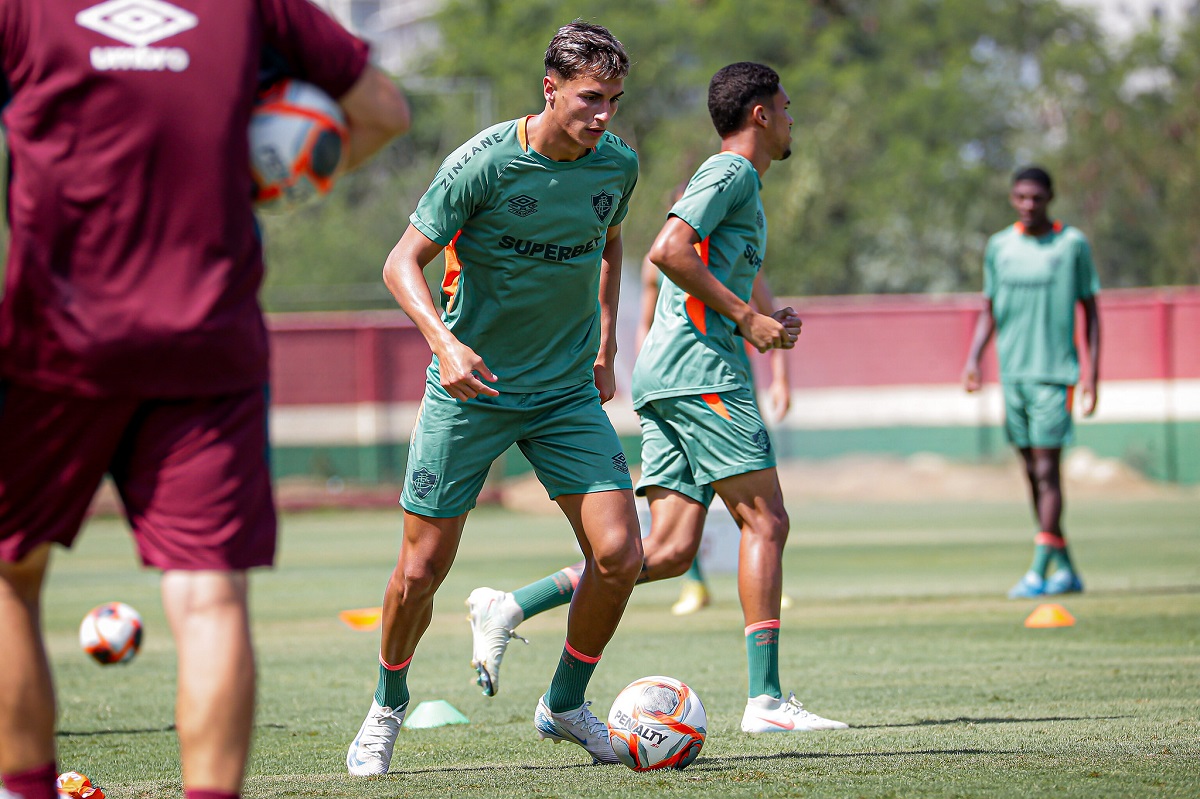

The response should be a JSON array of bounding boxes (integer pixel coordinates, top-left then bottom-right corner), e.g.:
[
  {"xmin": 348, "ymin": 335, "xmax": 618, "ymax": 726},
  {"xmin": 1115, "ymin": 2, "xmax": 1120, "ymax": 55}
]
[{"xmin": 409, "ymin": 118, "xmax": 637, "ymax": 392}]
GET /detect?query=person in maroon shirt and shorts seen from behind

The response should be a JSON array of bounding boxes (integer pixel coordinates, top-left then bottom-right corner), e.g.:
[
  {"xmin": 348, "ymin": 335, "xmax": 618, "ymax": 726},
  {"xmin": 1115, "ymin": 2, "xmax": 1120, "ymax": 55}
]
[{"xmin": 0, "ymin": 0, "xmax": 409, "ymax": 799}]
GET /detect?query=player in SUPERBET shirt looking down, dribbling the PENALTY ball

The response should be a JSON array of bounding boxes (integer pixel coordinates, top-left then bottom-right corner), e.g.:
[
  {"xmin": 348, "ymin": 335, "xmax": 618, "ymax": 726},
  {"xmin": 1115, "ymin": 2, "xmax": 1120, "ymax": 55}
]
[{"xmin": 346, "ymin": 20, "xmax": 642, "ymax": 775}]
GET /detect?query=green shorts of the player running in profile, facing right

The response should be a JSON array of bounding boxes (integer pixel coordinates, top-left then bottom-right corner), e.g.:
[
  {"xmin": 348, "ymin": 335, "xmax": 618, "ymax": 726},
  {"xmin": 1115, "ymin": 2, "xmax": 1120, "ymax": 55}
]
[{"xmin": 637, "ymin": 389, "xmax": 775, "ymax": 506}]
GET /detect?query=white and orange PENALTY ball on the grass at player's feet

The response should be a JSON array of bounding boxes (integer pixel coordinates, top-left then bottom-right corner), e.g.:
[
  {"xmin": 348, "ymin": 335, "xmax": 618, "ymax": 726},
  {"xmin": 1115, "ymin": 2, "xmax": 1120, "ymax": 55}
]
[{"xmin": 608, "ymin": 677, "xmax": 708, "ymax": 771}]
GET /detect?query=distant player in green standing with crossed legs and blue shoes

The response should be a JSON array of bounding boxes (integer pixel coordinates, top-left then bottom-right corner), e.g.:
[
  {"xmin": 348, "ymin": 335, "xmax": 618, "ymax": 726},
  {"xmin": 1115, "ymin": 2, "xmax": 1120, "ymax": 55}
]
[{"xmin": 962, "ymin": 167, "xmax": 1100, "ymax": 599}]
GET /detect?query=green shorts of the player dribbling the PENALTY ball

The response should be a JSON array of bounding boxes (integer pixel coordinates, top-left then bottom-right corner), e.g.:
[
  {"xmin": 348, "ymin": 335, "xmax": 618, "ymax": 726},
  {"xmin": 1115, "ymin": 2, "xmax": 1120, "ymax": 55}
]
[{"xmin": 400, "ymin": 380, "xmax": 632, "ymax": 518}]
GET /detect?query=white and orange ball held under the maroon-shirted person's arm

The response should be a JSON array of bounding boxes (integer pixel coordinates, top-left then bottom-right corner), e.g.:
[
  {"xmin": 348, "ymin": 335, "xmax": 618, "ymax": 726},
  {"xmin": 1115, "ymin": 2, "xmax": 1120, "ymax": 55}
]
[{"xmin": 250, "ymin": 78, "xmax": 348, "ymax": 211}]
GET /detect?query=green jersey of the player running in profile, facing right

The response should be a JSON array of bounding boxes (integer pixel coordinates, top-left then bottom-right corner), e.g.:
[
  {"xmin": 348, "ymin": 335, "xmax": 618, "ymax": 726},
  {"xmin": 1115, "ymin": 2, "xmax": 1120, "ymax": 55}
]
[{"xmin": 632, "ymin": 152, "xmax": 767, "ymax": 408}]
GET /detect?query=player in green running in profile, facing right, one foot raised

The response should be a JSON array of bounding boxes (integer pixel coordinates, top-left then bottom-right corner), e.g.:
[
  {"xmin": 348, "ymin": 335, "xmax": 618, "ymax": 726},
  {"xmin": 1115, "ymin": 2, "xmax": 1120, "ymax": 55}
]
[{"xmin": 468, "ymin": 62, "xmax": 846, "ymax": 733}]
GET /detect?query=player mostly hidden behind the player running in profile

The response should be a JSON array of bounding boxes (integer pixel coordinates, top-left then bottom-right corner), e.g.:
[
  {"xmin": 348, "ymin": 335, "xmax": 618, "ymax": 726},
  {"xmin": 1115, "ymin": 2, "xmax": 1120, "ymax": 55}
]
[{"xmin": 637, "ymin": 209, "xmax": 794, "ymax": 615}]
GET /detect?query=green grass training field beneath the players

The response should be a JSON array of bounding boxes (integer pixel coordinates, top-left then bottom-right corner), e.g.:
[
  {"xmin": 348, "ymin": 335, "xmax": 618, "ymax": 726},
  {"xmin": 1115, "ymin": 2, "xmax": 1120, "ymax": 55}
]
[{"xmin": 42, "ymin": 493, "xmax": 1200, "ymax": 799}]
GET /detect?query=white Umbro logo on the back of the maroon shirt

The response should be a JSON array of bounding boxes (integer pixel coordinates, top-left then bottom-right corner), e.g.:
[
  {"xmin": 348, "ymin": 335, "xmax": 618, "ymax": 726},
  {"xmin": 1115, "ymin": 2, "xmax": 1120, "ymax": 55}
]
[{"xmin": 76, "ymin": 0, "xmax": 199, "ymax": 72}]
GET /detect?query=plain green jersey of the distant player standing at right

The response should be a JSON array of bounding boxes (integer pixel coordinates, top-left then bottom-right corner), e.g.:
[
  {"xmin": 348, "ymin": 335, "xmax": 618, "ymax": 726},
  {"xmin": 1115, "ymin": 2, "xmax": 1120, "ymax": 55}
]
[{"xmin": 983, "ymin": 222, "xmax": 1100, "ymax": 385}]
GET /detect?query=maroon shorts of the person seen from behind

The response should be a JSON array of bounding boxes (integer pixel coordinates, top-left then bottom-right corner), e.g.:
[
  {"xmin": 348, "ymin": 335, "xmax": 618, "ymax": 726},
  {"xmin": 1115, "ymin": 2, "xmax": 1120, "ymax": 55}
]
[{"xmin": 0, "ymin": 382, "xmax": 275, "ymax": 571}]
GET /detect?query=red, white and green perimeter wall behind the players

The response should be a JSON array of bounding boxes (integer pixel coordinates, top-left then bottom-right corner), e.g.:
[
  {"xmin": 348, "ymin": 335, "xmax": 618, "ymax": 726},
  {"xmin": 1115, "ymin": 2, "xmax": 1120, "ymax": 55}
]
[{"xmin": 270, "ymin": 288, "xmax": 1200, "ymax": 482}]
